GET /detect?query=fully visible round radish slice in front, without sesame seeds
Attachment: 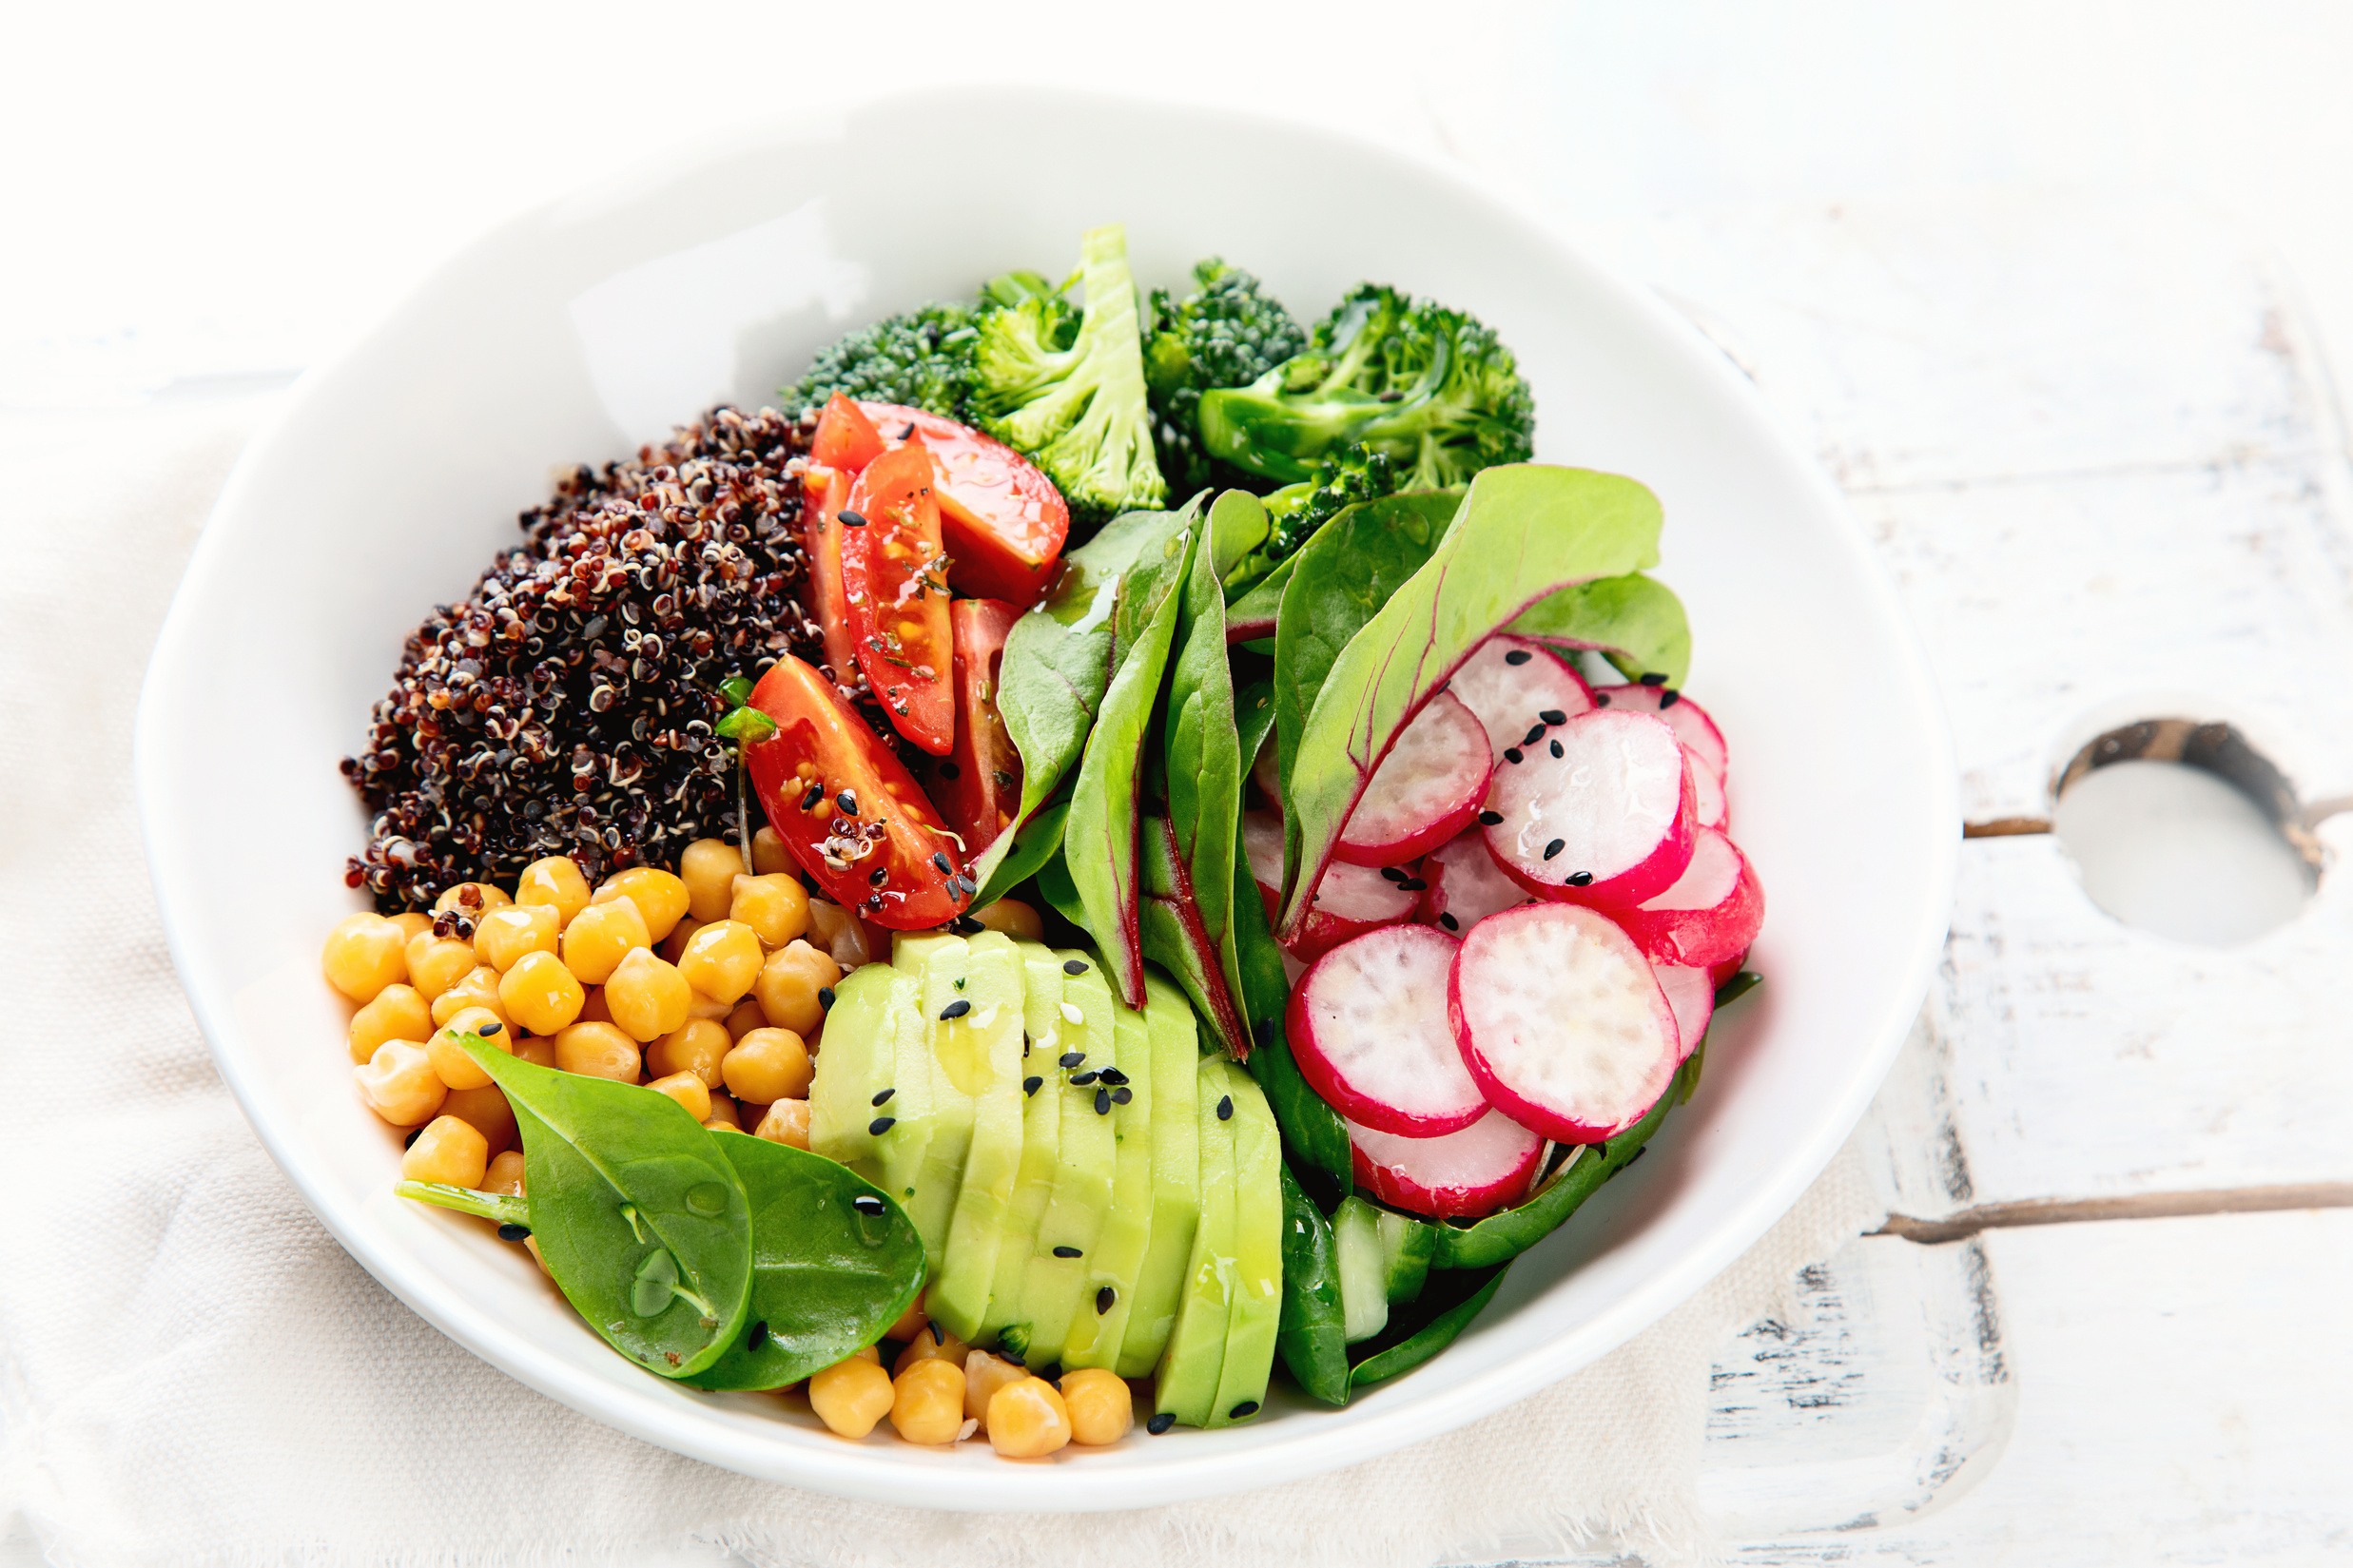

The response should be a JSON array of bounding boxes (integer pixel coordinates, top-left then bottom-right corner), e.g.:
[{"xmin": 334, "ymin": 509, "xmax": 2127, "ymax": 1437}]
[{"xmin": 1448, "ymin": 902, "xmax": 1682, "ymax": 1143}]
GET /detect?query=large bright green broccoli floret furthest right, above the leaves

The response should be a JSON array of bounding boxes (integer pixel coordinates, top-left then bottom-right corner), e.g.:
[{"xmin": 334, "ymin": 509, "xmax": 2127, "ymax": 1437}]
[{"xmin": 1200, "ymin": 282, "xmax": 1537, "ymax": 489}]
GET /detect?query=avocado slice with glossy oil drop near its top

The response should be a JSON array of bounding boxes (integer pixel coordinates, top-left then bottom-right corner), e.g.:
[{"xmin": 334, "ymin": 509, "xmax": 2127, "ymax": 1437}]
[{"xmin": 922, "ymin": 931, "xmax": 1023, "ymax": 1343}]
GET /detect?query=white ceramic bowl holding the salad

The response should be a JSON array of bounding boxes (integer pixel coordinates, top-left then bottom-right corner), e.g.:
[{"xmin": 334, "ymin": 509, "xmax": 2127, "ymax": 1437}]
[{"xmin": 136, "ymin": 91, "xmax": 1957, "ymax": 1512}]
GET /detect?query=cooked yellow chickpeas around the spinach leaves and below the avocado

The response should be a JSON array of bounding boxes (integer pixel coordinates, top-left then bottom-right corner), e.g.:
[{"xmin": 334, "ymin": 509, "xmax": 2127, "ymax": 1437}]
[{"xmin": 320, "ymin": 846, "xmax": 1134, "ymax": 1460}]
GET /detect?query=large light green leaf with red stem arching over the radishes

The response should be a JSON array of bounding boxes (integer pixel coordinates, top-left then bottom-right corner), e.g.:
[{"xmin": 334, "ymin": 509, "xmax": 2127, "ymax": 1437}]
[{"xmin": 1275, "ymin": 463, "xmax": 1659, "ymax": 931}]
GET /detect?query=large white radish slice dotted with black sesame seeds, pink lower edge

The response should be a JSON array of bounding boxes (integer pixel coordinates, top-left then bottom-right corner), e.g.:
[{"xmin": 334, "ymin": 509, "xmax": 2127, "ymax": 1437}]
[{"xmin": 1480, "ymin": 710, "xmax": 1697, "ymax": 910}]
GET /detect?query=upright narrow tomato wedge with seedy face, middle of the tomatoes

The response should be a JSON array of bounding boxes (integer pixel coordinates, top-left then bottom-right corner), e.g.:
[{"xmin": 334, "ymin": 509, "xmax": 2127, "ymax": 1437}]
[{"xmin": 840, "ymin": 447, "xmax": 955, "ymax": 757}]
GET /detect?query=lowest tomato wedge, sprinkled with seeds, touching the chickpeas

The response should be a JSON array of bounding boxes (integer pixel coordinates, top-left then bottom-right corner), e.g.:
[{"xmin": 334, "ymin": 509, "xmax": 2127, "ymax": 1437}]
[{"xmin": 744, "ymin": 656, "xmax": 977, "ymax": 931}]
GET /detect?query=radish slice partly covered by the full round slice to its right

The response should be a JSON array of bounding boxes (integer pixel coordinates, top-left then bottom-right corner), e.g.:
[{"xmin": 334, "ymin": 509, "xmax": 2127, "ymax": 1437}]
[{"xmin": 1285, "ymin": 926, "xmax": 1488, "ymax": 1138}]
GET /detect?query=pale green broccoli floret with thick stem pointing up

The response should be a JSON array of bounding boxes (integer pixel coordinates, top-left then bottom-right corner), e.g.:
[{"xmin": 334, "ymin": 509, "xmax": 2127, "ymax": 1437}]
[{"xmin": 969, "ymin": 223, "xmax": 1167, "ymax": 522}]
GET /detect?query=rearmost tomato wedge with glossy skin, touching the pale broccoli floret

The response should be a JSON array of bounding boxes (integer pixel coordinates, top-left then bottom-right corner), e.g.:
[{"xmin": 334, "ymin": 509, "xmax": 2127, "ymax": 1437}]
[{"xmin": 859, "ymin": 402, "xmax": 1071, "ymax": 607}]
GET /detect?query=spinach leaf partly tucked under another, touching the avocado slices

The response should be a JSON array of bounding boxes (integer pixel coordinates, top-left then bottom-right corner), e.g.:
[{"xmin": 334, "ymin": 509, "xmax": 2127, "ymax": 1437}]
[{"xmin": 687, "ymin": 1131, "xmax": 924, "ymax": 1389}]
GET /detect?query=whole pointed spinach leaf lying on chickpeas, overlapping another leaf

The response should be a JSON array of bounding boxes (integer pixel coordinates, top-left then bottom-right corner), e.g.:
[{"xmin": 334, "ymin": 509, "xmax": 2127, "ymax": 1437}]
[{"xmin": 458, "ymin": 1035, "xmax": 753, "ymax": 1378}]
